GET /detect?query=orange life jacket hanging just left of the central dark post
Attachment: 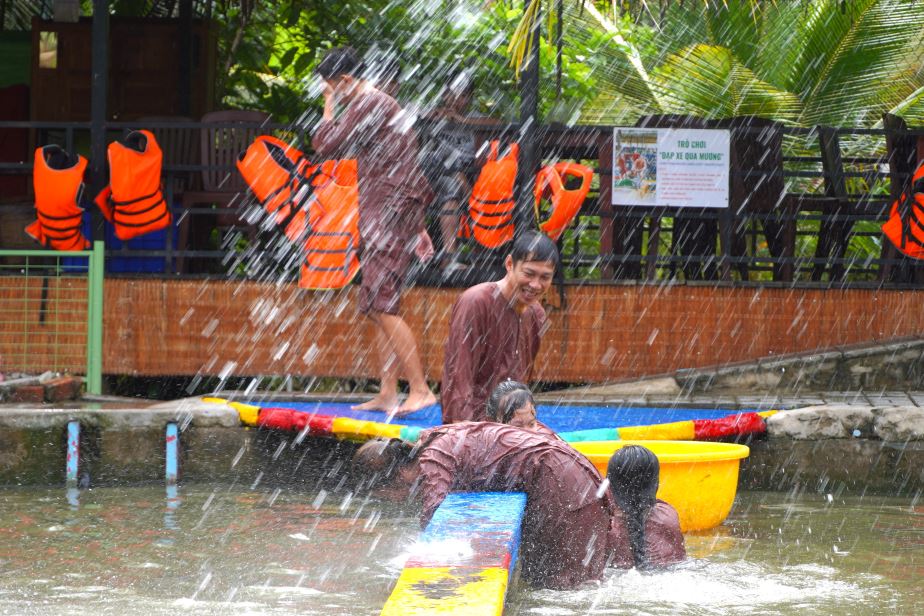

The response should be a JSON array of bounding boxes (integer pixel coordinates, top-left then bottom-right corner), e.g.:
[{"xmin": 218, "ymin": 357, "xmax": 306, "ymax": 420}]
[{"xmin": 468, "ymin": 141, "xmax": 520, "ymax": 248}]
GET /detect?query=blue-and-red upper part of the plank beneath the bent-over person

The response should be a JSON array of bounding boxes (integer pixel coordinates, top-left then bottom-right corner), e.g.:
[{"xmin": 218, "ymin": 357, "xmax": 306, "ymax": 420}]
[{"xmin": 405, "ymin": 492, "xmax": 526, "ymax": 572}]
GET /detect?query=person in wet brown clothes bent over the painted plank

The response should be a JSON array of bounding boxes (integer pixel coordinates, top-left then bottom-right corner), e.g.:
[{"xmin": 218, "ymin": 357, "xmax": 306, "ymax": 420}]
[{"xmin": 357, "ymin": 422, "xmax": 615, "ymax": 589}]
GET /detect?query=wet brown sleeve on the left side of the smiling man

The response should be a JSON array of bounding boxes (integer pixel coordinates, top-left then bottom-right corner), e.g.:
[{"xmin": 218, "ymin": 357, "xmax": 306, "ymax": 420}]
[{"xmin": 440, "ymin": 295, "xmax": 484, "ymax": 423}]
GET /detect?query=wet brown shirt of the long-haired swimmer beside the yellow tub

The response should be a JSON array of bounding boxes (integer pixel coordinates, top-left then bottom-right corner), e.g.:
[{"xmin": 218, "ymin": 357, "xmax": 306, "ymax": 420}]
[{"xmin": 610, "ymin": 499, "xmax": 687, "ymax": 569}]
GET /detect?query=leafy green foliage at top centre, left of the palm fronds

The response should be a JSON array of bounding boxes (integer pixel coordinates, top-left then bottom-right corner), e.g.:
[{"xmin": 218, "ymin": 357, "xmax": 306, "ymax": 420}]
[{"xmin": 218, "ymin": 0, "xmax": 605, "ymax": 122}]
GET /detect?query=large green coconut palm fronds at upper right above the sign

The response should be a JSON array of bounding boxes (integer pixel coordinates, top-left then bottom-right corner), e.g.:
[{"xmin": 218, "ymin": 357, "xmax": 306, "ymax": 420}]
[{"xmin": 510, "ymin": 0, "xmax": 924, "ymax": 126}]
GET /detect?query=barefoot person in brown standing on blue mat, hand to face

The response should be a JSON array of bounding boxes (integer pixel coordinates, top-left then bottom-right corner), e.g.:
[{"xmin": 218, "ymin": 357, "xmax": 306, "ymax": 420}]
[{"xmin": 312, "ymin": 47, "xmax": 436, "ymax": 413}]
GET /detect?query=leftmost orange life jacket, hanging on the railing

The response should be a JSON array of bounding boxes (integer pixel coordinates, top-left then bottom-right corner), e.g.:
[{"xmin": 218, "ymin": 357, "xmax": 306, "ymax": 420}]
[{"xmin": 26, "ymin": 145, "xmax": 90, "ymax": 250}]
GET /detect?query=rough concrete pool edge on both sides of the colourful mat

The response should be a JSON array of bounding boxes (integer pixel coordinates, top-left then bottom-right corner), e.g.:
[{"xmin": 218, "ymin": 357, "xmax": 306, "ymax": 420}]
[{"xmin": 0, "ymin": 398, "xmax": 924, "ymax": 496}]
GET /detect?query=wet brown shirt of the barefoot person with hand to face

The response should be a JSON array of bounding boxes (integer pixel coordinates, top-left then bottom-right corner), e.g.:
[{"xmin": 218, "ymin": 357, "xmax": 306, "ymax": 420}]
[{"xmin": 311, "ymin": 88, "xmax": 430, "ymax": 250}]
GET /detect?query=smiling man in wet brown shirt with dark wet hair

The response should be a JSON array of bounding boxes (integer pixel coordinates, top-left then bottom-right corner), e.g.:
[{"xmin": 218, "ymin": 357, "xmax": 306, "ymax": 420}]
[{"xmin": 440, "ymin": 231, "xmax": 558, "ymax": 424}]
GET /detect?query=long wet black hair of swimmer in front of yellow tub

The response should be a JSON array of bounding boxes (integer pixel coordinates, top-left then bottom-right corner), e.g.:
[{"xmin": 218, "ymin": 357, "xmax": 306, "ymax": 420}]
[{"xmin": 606, "ymin": 445, "xmax": 661, "ymax": 567}]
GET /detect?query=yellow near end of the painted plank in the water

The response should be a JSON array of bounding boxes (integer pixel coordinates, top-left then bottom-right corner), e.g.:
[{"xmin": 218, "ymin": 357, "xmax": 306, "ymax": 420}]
[{"xmin": 382, "ymin": 567, "xmax": 508, "ymax": 616}]
